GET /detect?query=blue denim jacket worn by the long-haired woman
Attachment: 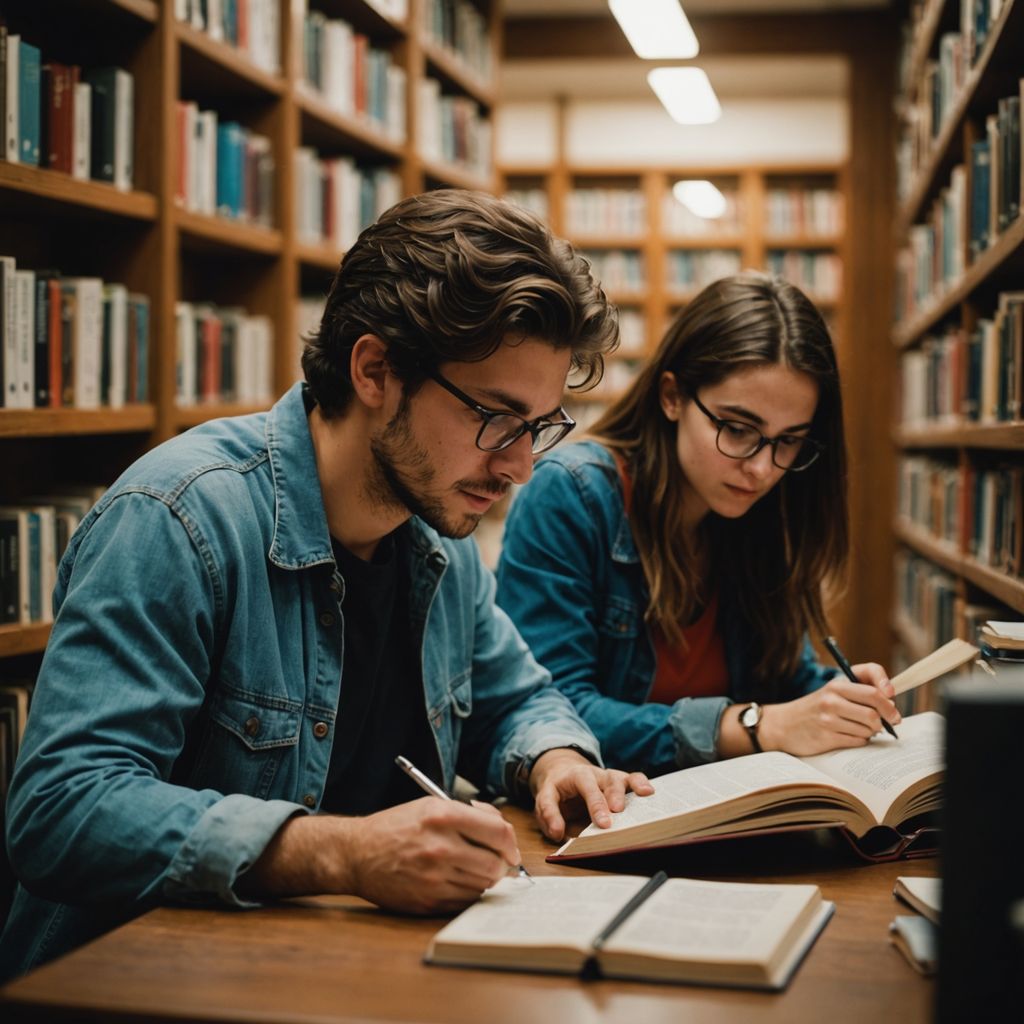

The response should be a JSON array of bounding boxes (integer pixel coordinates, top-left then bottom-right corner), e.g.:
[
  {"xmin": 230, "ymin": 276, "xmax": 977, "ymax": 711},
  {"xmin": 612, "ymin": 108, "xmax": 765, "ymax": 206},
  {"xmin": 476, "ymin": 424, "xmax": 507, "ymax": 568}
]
[{"xmin": 498, "ymin": 441, "xmax": 835, "ymax": 774}]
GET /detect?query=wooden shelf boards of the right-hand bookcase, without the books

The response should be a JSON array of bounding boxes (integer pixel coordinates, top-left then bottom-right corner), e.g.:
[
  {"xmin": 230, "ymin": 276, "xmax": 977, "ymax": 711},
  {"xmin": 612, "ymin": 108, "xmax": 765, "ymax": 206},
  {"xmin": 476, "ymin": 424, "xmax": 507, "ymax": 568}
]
[{"xmin": 892, "ymin": 0, "xmax": 1024, "ymax": 655}]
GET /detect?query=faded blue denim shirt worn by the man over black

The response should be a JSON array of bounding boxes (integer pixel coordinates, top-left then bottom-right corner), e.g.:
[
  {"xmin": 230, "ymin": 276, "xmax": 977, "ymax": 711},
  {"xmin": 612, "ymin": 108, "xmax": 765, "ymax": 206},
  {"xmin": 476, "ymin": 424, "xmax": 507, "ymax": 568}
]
[{"xmin": 0, "ymin": 385, "xmax": 599, "ymax": 975}]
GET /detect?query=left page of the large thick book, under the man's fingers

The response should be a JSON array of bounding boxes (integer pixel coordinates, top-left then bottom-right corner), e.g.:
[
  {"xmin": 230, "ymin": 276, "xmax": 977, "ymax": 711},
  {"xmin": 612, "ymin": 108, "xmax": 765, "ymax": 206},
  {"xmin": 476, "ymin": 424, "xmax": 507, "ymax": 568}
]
[{"xmin": 581, "ymin": 751, "xmax": 836, "ymax": 836}]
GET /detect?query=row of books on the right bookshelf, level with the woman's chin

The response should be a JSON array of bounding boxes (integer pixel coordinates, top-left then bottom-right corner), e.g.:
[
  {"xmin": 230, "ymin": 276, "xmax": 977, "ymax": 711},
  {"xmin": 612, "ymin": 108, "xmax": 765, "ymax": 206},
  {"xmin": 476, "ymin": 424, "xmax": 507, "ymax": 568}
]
[{"xmin": 897, "ymin": 456, "xmax": 1024, "ymax": 577}]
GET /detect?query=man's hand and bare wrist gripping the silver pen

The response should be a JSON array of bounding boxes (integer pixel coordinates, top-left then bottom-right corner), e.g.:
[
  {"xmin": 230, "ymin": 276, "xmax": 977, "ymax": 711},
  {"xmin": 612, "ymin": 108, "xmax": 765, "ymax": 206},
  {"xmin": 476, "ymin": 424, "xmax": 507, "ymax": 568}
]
[{"xmin": 237, "ymin": 797, "xmax": 521, "ymax": 913}]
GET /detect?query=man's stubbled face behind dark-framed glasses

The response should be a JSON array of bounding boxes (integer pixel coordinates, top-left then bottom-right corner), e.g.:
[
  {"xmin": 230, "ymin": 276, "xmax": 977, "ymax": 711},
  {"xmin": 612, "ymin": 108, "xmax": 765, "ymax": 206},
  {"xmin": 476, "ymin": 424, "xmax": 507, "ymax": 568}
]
[{"xmin": 369, "ymin": 339, "xmax": 570, "ymax": 538}]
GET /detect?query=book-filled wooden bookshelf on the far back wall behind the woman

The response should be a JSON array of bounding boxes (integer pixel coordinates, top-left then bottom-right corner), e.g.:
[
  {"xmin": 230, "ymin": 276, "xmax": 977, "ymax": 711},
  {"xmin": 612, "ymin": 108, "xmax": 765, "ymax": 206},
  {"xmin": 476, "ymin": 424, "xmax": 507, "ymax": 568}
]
[{"xmin": 501, "ymin": 164, "xmax": 846, "ymax": 423}]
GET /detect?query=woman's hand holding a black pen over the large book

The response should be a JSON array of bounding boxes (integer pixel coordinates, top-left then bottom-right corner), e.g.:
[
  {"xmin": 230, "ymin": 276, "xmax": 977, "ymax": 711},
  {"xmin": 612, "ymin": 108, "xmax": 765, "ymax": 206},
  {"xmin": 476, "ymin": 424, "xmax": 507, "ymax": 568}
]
[{"xmin": 758, "ymin": 663, "xmax": 900, "ymax": 757}]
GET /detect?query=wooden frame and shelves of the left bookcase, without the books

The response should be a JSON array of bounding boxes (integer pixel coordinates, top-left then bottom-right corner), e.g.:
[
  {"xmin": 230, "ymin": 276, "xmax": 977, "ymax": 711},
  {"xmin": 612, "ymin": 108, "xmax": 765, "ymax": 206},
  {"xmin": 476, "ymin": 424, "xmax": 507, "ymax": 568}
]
[{"xmin": 0, "ymin": 0, "xmax": 501, "ymax": 663}]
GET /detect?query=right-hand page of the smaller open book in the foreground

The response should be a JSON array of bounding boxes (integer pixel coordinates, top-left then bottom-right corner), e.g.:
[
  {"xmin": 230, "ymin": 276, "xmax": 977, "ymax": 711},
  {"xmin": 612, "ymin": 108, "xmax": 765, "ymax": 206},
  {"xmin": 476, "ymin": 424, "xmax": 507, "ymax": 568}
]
[{"xmin": 604, "ymin": 879, "xmax": 818, "ymax": 964}]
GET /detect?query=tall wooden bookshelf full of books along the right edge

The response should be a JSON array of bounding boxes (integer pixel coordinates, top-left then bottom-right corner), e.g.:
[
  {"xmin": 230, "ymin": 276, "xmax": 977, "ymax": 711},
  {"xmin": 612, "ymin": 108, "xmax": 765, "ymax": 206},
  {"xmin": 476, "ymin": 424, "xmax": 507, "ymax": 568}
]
[{"xmin": 892, "ymin": 0, "xmax": 1024, "ymax": 659}]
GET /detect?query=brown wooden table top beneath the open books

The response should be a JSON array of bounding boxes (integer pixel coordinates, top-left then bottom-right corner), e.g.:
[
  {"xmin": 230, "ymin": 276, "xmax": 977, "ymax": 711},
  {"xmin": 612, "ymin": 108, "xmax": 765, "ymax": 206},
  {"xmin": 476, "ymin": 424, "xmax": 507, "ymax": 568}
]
[{"xmin": 0, "ymin": 808, "xmax": 937, "ymax": 1024}]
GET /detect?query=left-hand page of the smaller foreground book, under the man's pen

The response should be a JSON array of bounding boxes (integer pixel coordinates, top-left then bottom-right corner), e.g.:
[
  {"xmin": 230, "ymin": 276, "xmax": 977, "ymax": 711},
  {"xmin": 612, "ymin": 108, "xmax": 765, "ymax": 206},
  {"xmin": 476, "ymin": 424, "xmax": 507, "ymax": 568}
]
[{"xmin": 434, "ymin": 874, "xmax": 647, "ymax": 950}]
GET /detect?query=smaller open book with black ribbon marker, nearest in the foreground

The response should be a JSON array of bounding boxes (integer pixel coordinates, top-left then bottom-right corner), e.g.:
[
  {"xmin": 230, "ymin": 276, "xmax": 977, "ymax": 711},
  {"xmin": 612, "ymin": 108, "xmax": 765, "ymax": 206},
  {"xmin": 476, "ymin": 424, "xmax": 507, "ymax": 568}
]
[{"xmin": 426, "ymin": 873, "xmax": 834, "ymax": 989}]
